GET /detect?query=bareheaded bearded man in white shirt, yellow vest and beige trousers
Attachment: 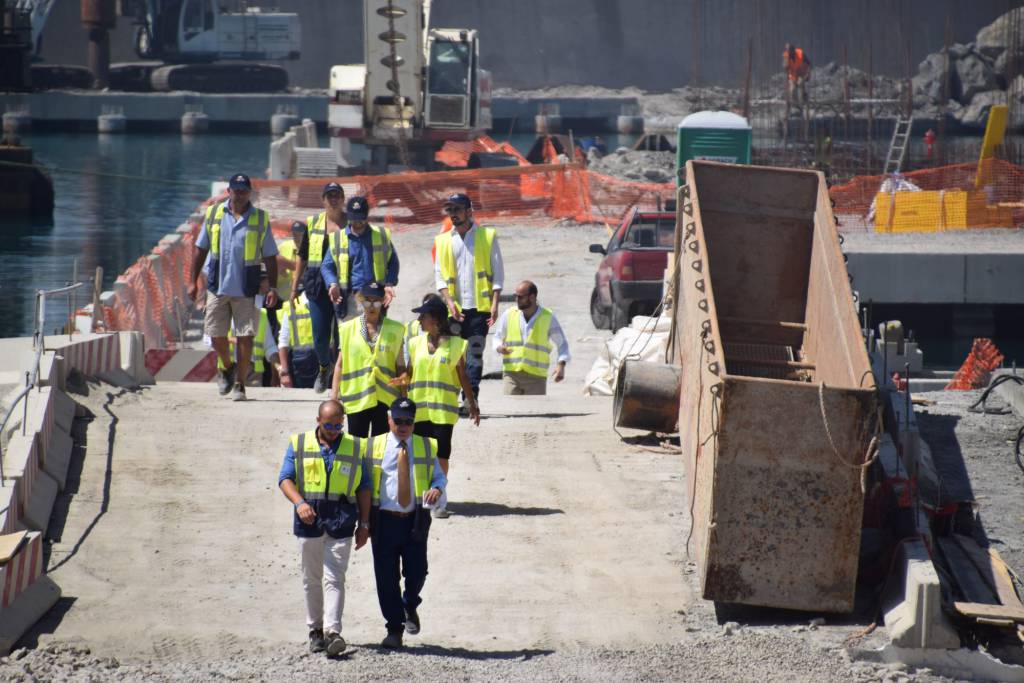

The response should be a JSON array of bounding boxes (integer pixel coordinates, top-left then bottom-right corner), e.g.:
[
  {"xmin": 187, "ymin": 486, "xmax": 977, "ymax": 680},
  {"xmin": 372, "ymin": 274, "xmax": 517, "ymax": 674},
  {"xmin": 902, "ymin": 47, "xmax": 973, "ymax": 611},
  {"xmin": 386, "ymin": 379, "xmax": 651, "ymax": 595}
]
[{"xmin": 495, "ymin": 280, "xmax": 569, "ymax": 395}]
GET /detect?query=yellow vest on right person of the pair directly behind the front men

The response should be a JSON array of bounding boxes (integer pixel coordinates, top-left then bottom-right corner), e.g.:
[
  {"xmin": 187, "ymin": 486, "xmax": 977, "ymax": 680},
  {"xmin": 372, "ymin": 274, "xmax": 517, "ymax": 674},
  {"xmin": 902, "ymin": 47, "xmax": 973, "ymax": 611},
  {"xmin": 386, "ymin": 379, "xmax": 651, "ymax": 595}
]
[{"xmin": 409, "ymin": 335, "xmax": 468, "ymax": 425}]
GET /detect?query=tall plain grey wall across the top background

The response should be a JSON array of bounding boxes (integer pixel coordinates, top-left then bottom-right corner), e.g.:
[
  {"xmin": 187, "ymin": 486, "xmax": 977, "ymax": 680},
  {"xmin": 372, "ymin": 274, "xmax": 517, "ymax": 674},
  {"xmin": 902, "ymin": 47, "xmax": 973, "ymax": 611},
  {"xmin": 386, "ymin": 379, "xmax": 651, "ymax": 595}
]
[{"xmin": 36, "ymin": 0, "xmax": 1022, "ymax": 90}]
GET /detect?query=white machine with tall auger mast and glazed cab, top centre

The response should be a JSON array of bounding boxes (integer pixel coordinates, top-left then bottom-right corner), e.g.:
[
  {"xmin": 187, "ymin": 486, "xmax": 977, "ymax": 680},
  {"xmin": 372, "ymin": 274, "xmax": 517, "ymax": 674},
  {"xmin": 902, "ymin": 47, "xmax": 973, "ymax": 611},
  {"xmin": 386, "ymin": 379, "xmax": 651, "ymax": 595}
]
[{"xmin": 328, "ymin": 0, "xmax": 492, "ymax": 173}]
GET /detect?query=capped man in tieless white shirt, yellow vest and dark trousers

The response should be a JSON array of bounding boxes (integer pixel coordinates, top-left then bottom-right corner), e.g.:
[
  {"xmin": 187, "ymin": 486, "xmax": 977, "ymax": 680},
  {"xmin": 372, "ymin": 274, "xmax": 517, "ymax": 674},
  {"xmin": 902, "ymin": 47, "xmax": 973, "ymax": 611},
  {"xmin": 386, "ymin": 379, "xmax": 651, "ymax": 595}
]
[{"xmin": 434, "ymin": 193, "xmax": 505, "ymax": 416}]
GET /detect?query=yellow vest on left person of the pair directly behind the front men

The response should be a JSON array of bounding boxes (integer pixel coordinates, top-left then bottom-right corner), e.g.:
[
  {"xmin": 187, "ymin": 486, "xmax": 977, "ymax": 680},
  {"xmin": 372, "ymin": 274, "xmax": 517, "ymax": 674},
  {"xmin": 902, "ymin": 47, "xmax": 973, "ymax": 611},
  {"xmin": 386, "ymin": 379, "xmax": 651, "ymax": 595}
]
[{"xmin": 338, "ymin": 317, "xmax": 406, "ymax": 414}]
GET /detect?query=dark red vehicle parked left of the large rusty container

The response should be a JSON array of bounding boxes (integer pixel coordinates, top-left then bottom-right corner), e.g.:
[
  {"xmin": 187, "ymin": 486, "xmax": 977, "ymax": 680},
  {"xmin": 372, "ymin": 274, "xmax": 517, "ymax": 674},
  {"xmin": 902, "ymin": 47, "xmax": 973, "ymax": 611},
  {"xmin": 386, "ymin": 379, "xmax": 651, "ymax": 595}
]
[{"xmin": 590, "ymin": 207, "xmax": 676, "ymax": 331}]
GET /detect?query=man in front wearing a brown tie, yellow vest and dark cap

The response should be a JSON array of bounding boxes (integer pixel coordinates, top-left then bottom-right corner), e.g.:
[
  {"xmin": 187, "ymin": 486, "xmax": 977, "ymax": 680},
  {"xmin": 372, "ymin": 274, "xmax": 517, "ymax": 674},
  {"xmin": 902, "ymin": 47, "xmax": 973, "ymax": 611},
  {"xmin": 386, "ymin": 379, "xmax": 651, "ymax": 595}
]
[{"xmin": 368, "ymin": 398, "xmax": 447, "ymax": 649}]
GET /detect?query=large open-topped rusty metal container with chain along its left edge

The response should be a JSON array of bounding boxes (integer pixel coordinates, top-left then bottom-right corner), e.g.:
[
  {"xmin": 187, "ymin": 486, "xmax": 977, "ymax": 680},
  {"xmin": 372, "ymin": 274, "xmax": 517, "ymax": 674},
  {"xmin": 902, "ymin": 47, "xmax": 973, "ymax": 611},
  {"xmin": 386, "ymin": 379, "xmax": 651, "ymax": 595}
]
[{"xmin": 671, "ymin": 162, "xmax": 877, "ymax": 612}]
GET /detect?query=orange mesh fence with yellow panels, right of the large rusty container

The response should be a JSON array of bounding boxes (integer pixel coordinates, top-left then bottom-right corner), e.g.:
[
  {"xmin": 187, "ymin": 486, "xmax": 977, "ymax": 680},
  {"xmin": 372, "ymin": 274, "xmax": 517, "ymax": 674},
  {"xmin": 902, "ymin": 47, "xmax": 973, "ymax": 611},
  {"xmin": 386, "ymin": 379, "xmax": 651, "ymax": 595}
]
[{"xmin": 829, "ymin": 159, "xmax": 1024, "ymax": 232}]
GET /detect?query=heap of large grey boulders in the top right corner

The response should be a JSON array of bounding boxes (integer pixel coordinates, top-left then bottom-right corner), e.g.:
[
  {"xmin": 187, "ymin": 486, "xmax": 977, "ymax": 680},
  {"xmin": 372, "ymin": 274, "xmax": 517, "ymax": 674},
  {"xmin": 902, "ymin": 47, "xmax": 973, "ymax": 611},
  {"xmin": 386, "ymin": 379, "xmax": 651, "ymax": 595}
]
[{"xmin": 912, "ymin": 7, "xmax": 1024, "ymax": 129}]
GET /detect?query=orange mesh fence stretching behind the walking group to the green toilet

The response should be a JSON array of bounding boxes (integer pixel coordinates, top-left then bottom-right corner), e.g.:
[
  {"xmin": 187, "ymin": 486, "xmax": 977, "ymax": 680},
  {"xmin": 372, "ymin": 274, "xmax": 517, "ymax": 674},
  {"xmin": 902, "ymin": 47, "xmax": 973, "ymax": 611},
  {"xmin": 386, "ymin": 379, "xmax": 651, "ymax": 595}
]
[{"xmin": 254, "ymin": 164, "xmax": 675, "ymax": 226}]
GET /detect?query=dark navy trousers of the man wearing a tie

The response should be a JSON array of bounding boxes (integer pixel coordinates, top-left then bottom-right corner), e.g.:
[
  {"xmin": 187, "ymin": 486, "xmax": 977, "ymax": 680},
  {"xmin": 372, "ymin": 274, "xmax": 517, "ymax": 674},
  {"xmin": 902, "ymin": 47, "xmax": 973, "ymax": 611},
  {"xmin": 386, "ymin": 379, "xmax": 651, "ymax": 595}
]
[{"xmin": 372, "ymin": 511, "xmax": 429, "ymax": 633}]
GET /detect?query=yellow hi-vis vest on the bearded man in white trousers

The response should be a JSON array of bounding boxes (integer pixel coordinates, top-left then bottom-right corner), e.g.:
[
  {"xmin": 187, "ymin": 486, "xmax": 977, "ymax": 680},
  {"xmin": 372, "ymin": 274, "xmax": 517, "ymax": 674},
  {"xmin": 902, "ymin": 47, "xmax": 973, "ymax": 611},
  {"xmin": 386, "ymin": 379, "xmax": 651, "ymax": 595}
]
[{"xmin": 291, "ymin": 430, "xmax": 367, "ymax": 502}]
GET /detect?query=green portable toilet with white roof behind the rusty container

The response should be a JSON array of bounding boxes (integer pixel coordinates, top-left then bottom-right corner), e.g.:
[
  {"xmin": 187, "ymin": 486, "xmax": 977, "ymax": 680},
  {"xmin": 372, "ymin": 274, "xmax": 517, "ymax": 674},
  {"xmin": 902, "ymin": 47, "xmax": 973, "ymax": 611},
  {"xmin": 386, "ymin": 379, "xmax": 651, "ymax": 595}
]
[{"xmin": 676, "ymin": 112, "xmax": 752, "ymax": 182}]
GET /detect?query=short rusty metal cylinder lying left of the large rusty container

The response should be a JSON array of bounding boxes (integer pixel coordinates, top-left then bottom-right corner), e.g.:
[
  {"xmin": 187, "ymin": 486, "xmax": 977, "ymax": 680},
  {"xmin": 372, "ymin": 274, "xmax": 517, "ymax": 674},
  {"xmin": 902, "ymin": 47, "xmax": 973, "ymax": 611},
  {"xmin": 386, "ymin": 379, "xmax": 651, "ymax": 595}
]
[{"xmin": 612, "ymin": 359, "xmax": 683, "ymax": 433}]
